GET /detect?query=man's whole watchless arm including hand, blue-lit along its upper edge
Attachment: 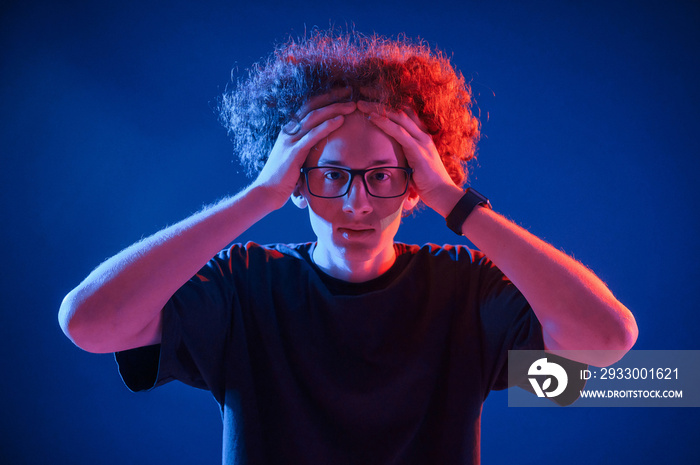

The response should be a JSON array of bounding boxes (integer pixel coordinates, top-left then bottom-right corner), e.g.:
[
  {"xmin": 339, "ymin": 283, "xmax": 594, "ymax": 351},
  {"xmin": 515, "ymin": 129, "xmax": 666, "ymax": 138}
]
[{"xmin": 58, "ymin": 89, "xmax": 355, "ymax": 353}]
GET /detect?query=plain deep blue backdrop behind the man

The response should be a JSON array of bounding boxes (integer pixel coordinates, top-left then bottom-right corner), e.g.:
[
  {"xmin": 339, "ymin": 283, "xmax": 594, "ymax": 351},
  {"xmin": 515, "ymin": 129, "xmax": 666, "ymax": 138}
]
[{"xmin": 0, "ymin": 0, "xmax": 700, "ymax": 465}]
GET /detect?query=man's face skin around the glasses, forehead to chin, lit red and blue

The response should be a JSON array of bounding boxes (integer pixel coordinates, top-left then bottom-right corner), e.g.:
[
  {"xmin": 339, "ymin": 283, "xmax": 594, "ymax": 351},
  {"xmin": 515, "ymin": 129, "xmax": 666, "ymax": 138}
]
[{"xmin": 301, "ymin": 111, "xmax": 412, "ymax": 263}]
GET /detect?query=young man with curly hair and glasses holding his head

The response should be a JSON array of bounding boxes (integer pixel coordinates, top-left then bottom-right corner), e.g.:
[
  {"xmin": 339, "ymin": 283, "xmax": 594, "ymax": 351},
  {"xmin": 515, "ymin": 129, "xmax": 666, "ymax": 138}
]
[{"xmin": 59, "ymin": 33, "xmax": 637, "ymax": 464}]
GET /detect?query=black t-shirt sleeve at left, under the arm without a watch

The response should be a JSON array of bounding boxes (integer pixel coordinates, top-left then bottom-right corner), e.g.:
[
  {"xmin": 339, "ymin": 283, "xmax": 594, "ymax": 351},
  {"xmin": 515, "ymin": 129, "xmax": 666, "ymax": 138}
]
[{"xmin": 115, "ymin": 247, "xmax": 245, "ymax": 392}]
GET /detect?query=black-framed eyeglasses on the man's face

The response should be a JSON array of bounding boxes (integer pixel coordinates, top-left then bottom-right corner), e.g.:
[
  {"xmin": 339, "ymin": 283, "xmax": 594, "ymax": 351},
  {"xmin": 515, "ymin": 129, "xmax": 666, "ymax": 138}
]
[{"xmin": 301, "ymin": 166, "xmax": 413, "ymax": 199}]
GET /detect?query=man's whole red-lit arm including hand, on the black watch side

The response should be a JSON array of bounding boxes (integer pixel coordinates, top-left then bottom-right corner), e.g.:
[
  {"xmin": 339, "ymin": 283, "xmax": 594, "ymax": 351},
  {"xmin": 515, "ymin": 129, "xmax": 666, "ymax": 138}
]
[{"xmin": 358, "ymin": 102, "xmax": 638, "ymax": 366}]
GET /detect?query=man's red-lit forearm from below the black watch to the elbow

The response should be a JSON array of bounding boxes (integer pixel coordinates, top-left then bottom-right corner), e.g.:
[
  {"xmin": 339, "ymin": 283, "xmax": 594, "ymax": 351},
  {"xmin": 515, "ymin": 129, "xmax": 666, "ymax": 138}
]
[{"xmin": 462, "ymin": 203, "xmax": 637, "ymax": 366}]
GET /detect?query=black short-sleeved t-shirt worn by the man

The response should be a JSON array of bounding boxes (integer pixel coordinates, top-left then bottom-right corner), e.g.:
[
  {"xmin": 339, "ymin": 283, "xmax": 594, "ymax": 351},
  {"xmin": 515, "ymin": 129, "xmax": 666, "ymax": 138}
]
[{"xmin": 117, "ymin": 243, "xmax": 544, "ymax": 465}]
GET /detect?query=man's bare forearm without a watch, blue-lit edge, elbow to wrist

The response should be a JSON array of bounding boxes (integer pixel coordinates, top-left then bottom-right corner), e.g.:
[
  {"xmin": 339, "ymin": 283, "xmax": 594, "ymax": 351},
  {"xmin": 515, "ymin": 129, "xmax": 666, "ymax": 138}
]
[{"xmin": 59, "ymin": 183, "xmax": 275, "ymax": 352}]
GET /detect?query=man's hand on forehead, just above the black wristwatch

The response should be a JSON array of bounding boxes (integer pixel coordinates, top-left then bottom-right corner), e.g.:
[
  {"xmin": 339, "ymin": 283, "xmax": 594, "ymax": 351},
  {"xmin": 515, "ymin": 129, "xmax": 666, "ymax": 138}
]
[{"xmin": 357, "ymin": 100, "xmax": 464, "ymax": 216}]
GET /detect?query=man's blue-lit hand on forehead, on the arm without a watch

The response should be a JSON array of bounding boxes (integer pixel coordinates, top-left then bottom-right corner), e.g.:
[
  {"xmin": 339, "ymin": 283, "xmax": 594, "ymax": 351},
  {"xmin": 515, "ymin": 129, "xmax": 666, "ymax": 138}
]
[{"xmin": 253, "ymin": 87, "xmax": 357, "ymax": 208}]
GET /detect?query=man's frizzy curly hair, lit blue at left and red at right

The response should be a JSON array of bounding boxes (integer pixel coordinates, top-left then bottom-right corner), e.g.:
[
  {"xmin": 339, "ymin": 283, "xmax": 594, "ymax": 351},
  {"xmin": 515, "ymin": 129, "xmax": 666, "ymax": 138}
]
[{"xmin": 219, "ymin": 30, "xmax": 480, "ymax": 186}]
